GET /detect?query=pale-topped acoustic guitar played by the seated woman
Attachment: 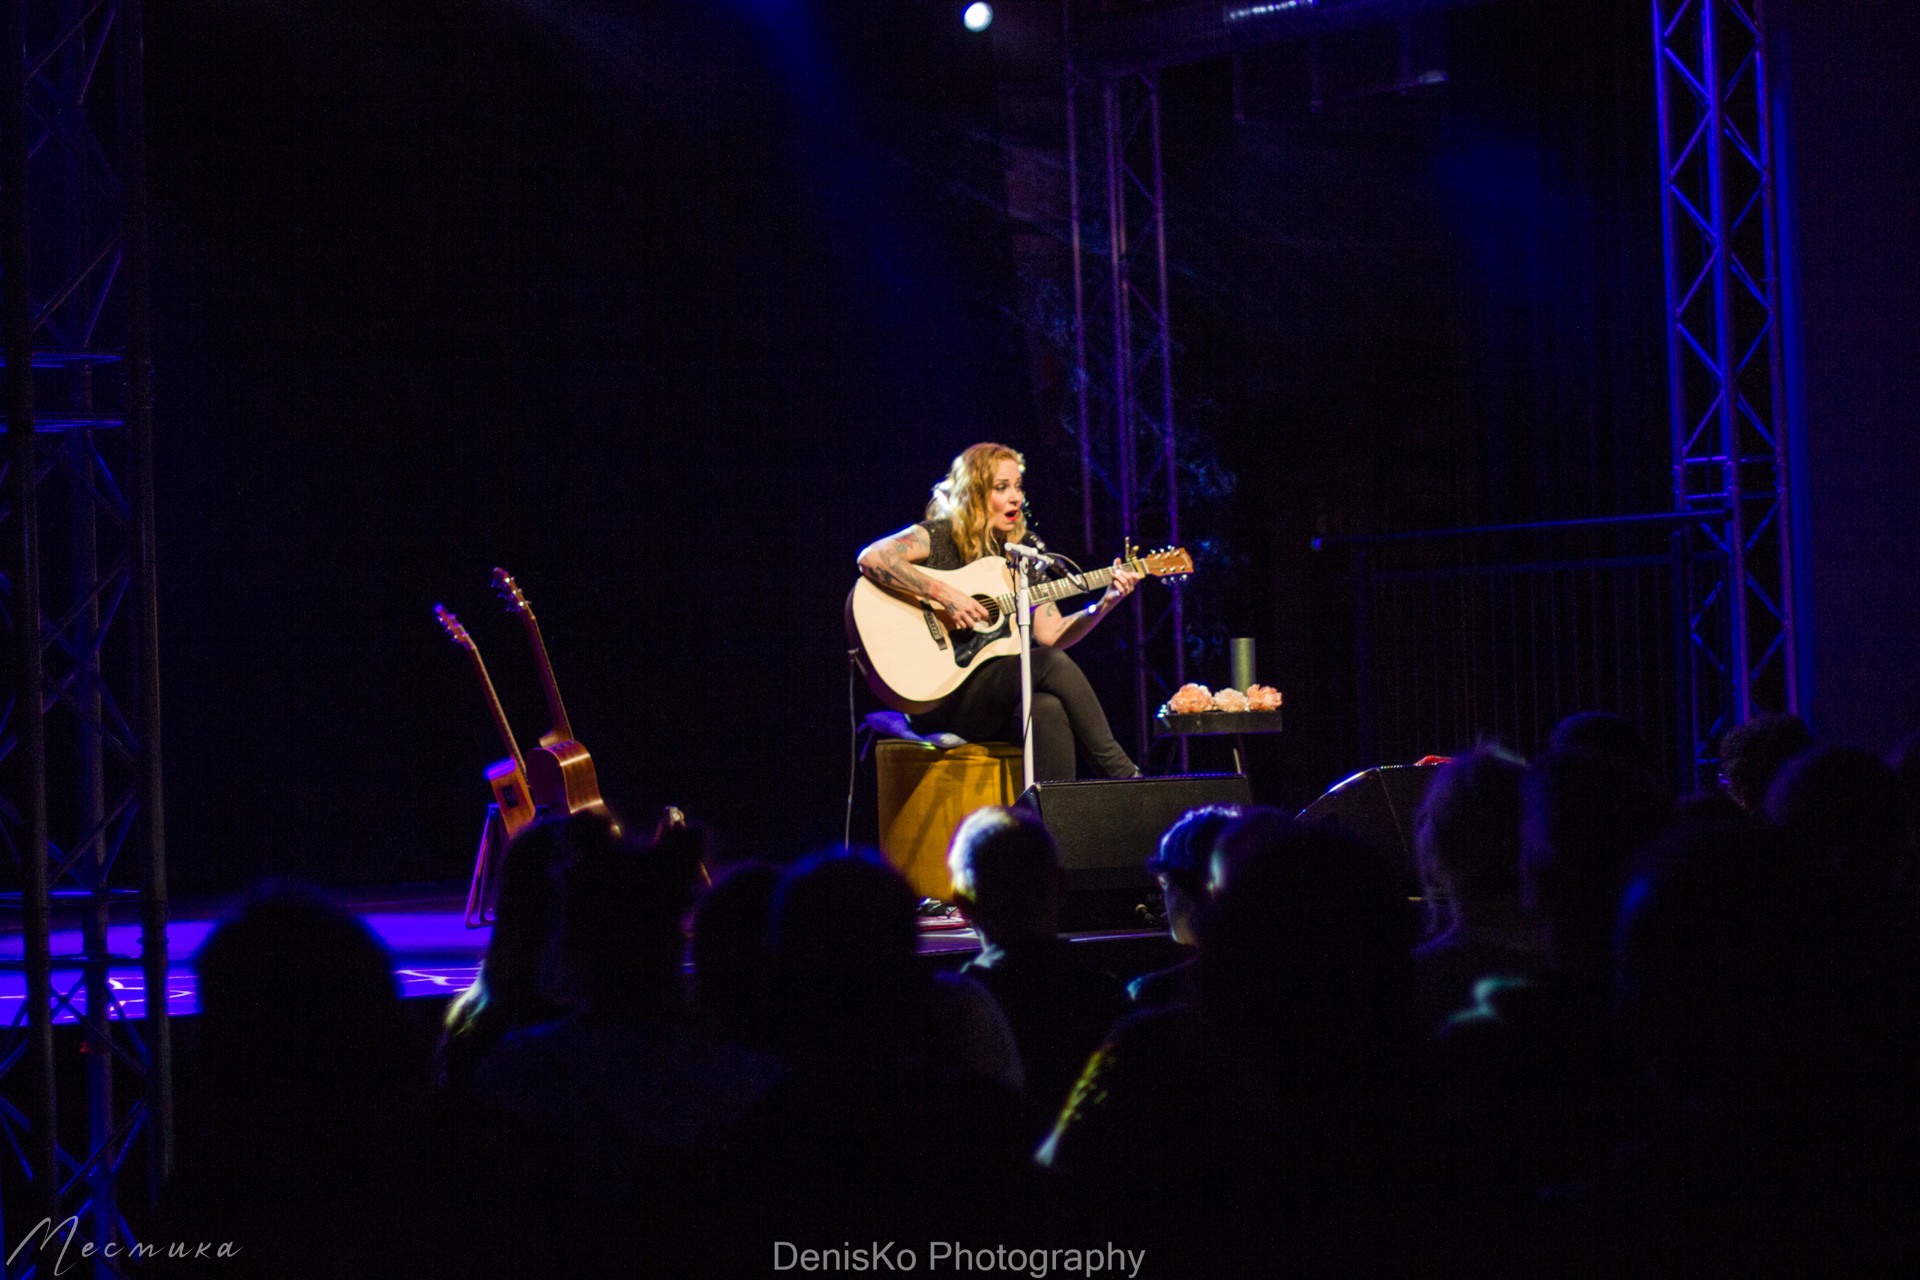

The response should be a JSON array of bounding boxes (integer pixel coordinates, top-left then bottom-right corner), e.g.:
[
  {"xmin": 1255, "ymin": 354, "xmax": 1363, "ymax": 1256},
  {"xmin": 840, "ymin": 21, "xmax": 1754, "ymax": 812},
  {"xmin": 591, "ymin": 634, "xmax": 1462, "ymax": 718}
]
[{"xmin": 847, "ymin": 547, "xmax": 1194, "ymax": 712}]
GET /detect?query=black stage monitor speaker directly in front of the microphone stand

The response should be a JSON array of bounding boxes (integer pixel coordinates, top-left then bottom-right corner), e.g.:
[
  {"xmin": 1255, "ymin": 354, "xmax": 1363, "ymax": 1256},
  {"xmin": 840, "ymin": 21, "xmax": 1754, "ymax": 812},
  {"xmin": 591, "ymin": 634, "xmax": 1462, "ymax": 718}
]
[{"xmin": 1020, "ymin": 773, "xmax": 1252, "ymax": 894}]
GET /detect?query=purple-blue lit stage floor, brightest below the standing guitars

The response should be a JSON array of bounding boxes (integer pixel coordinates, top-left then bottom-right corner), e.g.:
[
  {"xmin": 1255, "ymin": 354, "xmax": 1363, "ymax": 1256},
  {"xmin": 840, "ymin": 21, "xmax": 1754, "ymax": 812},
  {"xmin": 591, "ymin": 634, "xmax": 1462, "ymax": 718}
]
[{"xmin": 0, "ymin": 885, "xmax": 1165, "ymax": 1027}]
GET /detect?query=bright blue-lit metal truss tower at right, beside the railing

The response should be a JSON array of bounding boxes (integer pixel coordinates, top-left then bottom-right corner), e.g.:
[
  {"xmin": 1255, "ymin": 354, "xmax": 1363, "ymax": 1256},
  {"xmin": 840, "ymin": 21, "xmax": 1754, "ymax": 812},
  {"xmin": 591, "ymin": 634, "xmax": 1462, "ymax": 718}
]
[{"xmin": 1653, "ymin": 0, "xmax": 1799, "ymax": 775}]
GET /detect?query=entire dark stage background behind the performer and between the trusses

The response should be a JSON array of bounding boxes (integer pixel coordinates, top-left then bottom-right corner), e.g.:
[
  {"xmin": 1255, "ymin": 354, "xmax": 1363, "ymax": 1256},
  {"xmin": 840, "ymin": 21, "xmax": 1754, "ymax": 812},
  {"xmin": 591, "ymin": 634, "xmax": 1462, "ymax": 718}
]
[{"xmin": 148, "ymin": 0, "xmax": 1920, "ymax": 892}]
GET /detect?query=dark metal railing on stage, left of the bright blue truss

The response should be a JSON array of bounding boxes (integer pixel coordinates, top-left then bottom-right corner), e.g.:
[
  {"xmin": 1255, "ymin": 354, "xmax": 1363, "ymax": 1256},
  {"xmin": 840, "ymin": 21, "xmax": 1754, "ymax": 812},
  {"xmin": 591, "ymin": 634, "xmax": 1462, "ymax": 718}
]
[{"xmin": 1313, "ymin": 510, "xmax": 1728, "ymax": 787}]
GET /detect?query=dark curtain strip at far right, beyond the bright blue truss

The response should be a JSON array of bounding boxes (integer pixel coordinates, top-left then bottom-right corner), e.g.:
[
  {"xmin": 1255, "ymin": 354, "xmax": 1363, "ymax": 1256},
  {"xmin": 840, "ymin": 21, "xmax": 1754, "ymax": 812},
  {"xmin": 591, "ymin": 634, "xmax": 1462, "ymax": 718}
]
[{"xmin": 1774, "ymin": 0, "xmax": 1920, "ymax": 750}]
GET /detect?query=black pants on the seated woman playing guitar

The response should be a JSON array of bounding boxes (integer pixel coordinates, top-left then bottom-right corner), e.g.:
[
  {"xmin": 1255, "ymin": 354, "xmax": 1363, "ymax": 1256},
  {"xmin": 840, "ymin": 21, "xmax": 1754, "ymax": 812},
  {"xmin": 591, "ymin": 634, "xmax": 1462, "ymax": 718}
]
[{"xmin": 914, "ymin": 645, "xmax": 1139, "ymax": 781}]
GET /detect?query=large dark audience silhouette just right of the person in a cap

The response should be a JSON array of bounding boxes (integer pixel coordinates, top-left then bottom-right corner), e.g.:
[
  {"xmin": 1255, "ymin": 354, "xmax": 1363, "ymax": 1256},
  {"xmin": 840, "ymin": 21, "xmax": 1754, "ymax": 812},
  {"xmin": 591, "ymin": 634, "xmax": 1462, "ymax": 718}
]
[{"xmin": 1039, "ymin": 812, "xmax": 1428, "ymax": 1274}]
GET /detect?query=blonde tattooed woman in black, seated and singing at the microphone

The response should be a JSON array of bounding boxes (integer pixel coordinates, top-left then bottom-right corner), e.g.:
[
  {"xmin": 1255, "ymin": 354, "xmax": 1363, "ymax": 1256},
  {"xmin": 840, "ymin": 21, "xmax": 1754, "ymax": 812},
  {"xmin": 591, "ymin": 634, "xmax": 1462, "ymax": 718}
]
[{"xmin": 860, "ymin": 443, "xmax": 1140, "ymax": 781}]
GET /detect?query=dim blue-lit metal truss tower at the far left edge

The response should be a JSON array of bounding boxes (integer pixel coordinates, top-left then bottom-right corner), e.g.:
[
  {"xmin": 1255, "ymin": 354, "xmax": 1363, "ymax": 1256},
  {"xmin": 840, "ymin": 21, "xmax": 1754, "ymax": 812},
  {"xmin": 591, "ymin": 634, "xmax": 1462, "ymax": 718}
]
[{"xmin": 0, "ymin": 0, "xmax": 173, "ymax": 1274}]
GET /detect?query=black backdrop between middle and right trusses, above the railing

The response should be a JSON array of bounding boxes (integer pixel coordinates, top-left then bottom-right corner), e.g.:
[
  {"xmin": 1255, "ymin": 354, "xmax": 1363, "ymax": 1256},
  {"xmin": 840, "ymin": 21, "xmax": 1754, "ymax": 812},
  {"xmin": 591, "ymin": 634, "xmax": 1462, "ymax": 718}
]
[{"xmin": 1144, "ymin": 2, "xmax": 1670, "ymax": 808}]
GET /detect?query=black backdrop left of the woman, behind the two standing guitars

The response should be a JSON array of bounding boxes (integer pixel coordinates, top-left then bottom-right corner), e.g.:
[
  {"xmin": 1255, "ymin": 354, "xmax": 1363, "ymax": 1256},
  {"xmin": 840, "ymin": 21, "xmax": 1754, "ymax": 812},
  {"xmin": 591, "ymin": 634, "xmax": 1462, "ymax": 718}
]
[{"xmin": 150, "ymin": 2, "xmax": 1044, "ymax": 890}]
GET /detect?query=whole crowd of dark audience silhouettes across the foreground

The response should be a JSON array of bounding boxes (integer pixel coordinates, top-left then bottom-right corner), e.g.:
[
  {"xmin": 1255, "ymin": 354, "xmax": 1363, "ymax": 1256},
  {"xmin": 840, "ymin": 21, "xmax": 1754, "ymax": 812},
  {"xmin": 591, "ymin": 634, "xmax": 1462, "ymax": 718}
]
[{"xmin": 159, "ymin": 714, "xmax": 1920, "ymax": 1276}]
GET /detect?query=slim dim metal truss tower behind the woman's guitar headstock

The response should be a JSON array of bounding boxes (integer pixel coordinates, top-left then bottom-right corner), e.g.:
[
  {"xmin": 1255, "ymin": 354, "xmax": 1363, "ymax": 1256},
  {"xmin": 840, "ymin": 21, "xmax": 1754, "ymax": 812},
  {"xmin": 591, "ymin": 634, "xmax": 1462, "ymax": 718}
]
[{"xmin": 1068, "ymin": 65, "xmax": 1187, "ymax": 768}]
